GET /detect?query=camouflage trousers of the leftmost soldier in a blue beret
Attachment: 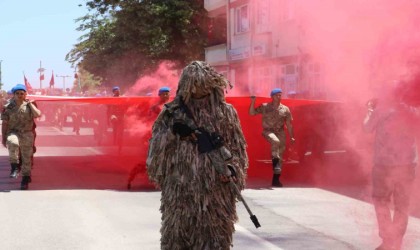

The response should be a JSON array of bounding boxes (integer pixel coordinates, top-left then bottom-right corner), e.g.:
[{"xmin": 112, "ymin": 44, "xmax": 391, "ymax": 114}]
[{"xmin": 6, "ymin": 131, "xmax": 35, "ymax": 176}]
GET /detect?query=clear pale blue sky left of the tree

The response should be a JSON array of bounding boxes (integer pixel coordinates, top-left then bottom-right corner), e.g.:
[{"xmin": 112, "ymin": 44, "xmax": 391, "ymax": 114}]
[{"xmin": 0, "ymin": 0, "xmax": 87, "ymax": 90}]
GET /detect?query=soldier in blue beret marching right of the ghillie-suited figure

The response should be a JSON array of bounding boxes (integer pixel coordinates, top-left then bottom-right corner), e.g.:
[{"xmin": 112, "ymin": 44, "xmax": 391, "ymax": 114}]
[{"xmin": 249, "ymin": 88, "xmax": 295, "ymax": 187}]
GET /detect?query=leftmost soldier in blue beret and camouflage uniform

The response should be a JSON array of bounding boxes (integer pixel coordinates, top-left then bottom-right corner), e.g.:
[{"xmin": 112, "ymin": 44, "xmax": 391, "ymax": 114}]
[{"xmin": 1, "ymin": 84, "xmax": 41, "ymax": 190}]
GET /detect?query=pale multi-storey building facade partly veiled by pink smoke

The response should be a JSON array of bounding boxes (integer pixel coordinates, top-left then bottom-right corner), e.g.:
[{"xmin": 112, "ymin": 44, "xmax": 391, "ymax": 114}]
[{"xmin": 204, "ymin": 0, "xmax": 328, "ymax": 99}]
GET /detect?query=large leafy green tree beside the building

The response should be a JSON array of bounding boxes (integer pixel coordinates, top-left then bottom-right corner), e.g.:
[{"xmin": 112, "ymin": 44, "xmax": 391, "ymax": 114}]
[{"xmin": 66, "ymin": 0, "xmax": 208, "ymax": 86}]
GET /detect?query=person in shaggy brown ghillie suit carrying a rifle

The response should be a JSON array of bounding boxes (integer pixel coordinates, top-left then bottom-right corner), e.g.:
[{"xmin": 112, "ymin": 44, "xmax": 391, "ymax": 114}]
[{"xmin": 146, "ymin": 61, "xmax": 248, "ymax": 250}]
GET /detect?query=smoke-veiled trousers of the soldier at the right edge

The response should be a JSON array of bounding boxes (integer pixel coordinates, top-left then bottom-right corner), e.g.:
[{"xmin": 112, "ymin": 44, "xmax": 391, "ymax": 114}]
[{"xmin": 372, "ymin": 165, "xmax": 415, "ymax": 245}]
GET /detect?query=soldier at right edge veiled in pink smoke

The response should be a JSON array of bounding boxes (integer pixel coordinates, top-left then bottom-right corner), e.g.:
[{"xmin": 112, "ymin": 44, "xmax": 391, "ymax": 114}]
[{"xmin": 363, "ymin": 85, "xmax": 420, "ymax": 250}]
